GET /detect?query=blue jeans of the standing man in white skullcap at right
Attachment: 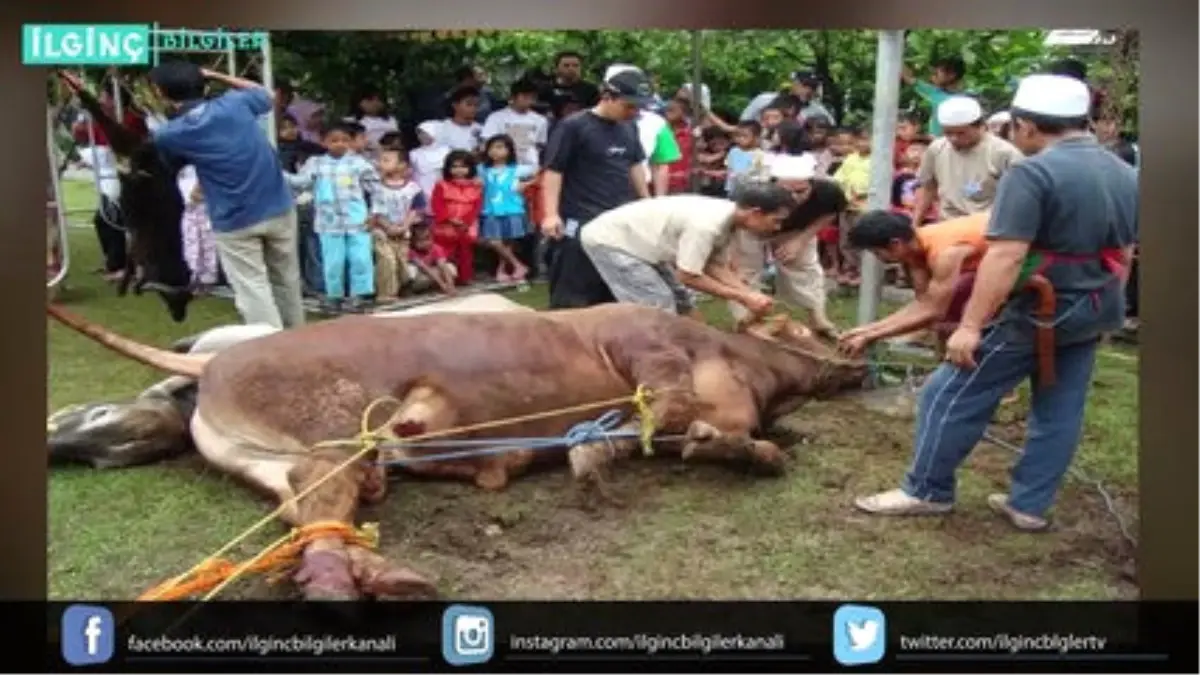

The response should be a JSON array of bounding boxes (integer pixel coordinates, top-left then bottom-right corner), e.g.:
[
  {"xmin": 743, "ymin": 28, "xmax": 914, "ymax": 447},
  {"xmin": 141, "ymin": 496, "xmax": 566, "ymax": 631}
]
[{"xmin": 901, "ymin": 289, "xmax": 1108, "ymax": 516}]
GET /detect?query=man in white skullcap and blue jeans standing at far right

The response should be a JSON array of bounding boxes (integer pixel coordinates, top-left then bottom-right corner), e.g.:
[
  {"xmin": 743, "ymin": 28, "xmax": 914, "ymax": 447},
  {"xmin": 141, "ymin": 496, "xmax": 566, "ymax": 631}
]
[{"xmin": 854, "ymin": 74, "xmax": 1138, "ymax": 531}]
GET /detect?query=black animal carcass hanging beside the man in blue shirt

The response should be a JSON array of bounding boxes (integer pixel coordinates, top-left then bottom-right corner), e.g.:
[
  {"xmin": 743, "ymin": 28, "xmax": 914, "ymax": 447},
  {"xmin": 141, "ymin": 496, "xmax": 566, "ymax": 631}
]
[{"xmin": 59, "ymin": 72, "xmax": 192, "ymax": 322}]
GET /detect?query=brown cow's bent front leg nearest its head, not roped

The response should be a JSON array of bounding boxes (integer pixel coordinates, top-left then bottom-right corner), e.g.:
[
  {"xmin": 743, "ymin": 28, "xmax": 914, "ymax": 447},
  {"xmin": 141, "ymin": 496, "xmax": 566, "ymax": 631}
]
[{"xmin": 683, "ymin": 360, "xmax": 786, "ymax": 473}]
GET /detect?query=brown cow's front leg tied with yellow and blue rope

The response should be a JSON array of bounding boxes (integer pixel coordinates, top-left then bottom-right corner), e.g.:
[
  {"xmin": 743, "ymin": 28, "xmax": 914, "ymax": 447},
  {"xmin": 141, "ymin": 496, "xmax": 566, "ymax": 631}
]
[{"xmin": 568, "ymin": 347, "xmax": 696, "ymax": 479}]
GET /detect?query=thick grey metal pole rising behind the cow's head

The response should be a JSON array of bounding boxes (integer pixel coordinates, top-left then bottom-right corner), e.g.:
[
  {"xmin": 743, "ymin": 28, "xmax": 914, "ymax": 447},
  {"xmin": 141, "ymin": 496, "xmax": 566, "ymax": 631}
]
[{"xmin": 858, "ymin": 30, "xmax": 904, "ymax": 325}]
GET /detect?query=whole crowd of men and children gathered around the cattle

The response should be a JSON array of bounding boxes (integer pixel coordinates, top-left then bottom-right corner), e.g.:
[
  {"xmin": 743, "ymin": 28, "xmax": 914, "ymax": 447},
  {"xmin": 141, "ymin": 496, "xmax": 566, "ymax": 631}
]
[{"xmin": 58, "ymin": 52, "xmax": 1139, "ymax": 530}]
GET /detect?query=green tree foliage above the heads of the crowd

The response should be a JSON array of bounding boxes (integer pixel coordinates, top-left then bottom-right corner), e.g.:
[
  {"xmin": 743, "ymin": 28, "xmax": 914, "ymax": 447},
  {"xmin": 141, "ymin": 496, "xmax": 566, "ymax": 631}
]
[{"xmin": 265, "ymin": 30, "xmax": 1136, "ymax": 128}]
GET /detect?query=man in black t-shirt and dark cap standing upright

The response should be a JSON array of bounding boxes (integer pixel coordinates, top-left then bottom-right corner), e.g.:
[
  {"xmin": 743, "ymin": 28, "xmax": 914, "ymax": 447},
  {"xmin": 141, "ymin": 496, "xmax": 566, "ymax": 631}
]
[{"xmin": 541, "ymin": 66, "xmax": 650, "ymax": 309}]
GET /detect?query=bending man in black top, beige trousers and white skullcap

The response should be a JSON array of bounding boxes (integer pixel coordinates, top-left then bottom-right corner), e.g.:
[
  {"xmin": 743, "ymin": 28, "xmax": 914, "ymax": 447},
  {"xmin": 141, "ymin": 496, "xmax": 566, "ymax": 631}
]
[{"xmin": 730, "ymin": 153, "xmax": 847, "ymax": 336}]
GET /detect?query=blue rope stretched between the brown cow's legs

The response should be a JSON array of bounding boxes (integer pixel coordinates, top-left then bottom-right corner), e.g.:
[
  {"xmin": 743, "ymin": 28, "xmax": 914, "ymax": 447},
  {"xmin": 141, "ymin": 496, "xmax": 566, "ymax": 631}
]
[{"xmin": 377, "ymin": 410, "xmax": 640, "ymax": 466}]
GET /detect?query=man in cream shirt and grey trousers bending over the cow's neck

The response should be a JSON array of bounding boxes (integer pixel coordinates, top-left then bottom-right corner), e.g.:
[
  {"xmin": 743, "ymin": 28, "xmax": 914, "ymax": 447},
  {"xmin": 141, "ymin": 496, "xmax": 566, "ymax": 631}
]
[{"xmin": 580, "ymin": 183, "xmax": 793, "ymax": 321}]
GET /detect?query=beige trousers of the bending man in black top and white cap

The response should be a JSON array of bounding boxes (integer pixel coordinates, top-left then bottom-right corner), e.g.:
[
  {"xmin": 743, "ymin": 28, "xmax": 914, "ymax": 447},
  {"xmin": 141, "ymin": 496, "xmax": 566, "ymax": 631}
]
[{"xmin": 730, "ymin": 229, "xmax": 826, "ymax": 321}]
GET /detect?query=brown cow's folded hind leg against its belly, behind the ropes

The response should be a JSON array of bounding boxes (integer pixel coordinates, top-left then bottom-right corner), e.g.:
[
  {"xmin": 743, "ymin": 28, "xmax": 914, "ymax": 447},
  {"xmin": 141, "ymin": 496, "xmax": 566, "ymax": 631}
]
[{"xmin": 382, "ymin": 382, "xmax": 521, "ymax": 490}]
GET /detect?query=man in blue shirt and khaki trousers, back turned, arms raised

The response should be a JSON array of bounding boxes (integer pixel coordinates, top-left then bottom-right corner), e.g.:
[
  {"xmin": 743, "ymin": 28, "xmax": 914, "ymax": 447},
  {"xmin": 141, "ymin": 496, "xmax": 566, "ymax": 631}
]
[{"xmin": 150, "ymin": 61, "xmax": 305, "ymax": 328}]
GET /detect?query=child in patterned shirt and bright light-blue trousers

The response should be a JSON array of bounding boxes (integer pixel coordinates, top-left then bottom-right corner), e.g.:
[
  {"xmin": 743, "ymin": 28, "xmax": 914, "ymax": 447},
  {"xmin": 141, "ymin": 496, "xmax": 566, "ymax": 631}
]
[{"xmin": 286, "ymin": 121, "xmax": 379, "ymax": 311}]
